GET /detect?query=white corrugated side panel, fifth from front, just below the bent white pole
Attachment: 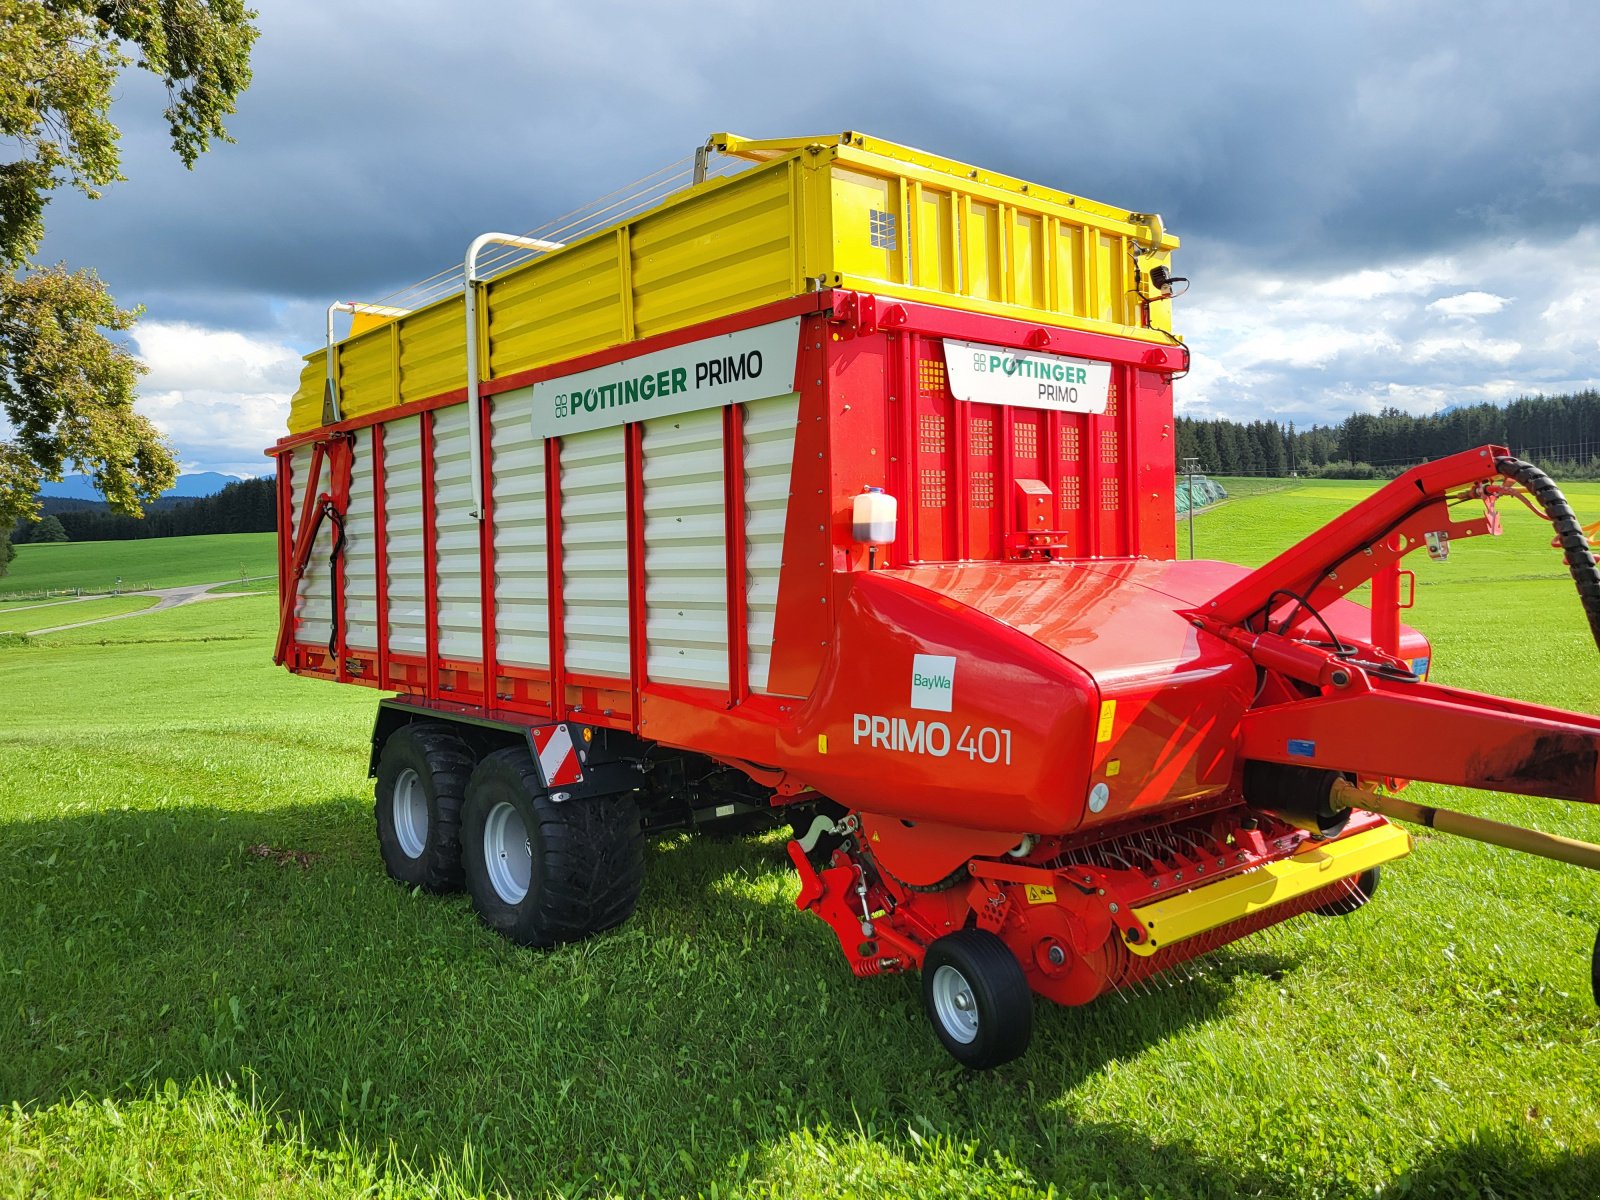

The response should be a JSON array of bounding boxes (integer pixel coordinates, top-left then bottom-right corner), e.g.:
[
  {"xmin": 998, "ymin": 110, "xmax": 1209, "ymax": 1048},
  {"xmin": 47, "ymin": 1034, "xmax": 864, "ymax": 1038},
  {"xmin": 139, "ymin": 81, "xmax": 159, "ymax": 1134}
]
[{"xmin": 434, "ymin": 405, "xmax": 483, "ymax": 662}]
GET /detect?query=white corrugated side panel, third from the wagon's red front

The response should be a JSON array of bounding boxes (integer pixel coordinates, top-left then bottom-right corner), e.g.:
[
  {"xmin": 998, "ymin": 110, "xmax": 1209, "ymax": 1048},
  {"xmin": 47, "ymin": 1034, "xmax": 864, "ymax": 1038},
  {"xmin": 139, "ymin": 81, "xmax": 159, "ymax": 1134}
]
[{"xmin": 562, "ymin": 426, "xmax": 630, "ymax": 680}]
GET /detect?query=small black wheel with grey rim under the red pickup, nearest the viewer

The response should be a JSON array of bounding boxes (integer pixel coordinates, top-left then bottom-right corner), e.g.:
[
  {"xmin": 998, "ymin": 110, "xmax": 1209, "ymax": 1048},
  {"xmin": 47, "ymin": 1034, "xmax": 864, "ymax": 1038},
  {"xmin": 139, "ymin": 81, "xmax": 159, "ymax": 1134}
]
[{"xmin": 922, "ymin": 930, "xmax": 1034, "ymax": 1070}]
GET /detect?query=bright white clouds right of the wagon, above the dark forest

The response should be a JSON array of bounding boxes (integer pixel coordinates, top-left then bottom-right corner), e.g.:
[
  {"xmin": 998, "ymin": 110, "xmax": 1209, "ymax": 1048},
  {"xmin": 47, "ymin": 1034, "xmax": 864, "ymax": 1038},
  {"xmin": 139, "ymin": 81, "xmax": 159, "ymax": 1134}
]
[{"xmin": 1176, "ymin": 227, "xmax": 1600, "ymax": 426}]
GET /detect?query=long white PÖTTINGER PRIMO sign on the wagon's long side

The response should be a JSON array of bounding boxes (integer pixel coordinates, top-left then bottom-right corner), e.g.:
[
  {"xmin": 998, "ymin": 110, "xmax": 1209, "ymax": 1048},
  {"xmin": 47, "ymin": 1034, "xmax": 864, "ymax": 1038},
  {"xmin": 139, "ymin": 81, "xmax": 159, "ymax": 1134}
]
[{"xmin": 521, "ymin": 317, "xmax": 800, "ymax": 437}]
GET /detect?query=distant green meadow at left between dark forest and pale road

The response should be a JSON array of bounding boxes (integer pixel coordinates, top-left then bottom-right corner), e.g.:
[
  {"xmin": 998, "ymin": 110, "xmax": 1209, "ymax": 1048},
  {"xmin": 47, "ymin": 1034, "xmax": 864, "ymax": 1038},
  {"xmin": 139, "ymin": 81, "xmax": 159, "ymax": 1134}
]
[{"xmin": 0, "ymin": 533, "xmax": 278, "ymax": 598}]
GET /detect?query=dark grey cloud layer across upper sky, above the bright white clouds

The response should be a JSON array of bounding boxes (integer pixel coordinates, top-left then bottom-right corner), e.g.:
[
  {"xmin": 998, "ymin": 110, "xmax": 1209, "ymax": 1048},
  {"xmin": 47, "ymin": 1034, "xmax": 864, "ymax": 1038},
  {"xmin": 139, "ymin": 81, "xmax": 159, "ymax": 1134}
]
[{"xmin": 37, "ymin": 0, "xmax": 1600, "ymax": 320}]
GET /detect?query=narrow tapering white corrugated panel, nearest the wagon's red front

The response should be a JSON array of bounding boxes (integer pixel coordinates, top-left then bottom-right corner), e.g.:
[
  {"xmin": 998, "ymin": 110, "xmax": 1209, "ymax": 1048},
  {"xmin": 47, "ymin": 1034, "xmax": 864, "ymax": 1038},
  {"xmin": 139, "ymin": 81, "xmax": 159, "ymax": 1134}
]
[{"xmin": 744, "ymin": 392, "xmax": 800, "ymax": 691}]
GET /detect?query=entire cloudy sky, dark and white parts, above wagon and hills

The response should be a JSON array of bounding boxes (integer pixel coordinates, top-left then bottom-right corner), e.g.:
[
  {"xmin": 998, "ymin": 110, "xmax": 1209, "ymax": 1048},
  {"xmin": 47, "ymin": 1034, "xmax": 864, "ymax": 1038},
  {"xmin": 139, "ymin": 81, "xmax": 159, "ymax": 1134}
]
[{"xmin": 21, "ymin": 0, "xmax": 1600, "ymax": 470}]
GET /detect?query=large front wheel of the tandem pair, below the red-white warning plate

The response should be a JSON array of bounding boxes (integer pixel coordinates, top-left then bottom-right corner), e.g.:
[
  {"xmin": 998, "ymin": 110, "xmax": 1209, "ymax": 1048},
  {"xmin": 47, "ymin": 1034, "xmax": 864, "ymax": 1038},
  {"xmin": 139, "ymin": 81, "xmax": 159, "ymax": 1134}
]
[{"xmin": 461, "ymin": 747, "xmax": 645, "ymax": 946}]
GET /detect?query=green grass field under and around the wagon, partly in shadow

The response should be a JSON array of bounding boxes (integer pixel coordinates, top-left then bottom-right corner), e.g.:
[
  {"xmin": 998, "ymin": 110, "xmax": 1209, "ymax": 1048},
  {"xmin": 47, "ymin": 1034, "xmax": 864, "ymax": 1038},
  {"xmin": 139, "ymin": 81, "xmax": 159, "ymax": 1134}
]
[{"xmin": 0, "ymin": 483, "xmax": 1600, "ymax": 1198}]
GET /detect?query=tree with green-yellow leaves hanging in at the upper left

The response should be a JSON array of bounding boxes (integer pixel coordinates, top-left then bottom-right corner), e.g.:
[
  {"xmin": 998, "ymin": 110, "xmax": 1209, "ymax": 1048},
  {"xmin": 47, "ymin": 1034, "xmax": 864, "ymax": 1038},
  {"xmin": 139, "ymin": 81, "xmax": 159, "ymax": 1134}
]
[{"xmin": 0, "ymin": 0, "xmax": 256, "ymax": 526}]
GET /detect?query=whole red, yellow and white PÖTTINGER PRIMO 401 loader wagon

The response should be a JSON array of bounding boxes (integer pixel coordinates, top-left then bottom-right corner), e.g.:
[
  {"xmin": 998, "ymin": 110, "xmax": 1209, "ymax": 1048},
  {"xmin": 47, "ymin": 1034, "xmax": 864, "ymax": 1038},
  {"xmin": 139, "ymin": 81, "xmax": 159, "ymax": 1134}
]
[{"xmin": 269, "ymin": 133, "xmax": 1600, "ymax": 1067}]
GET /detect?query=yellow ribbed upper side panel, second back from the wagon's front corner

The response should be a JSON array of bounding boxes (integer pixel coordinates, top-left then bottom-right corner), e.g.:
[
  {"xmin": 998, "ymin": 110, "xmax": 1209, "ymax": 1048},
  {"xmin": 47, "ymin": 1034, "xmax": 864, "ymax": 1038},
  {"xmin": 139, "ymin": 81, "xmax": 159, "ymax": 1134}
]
[{"xmin": 486, "ymin": 234, "xmax": 627, "ymax": 378}]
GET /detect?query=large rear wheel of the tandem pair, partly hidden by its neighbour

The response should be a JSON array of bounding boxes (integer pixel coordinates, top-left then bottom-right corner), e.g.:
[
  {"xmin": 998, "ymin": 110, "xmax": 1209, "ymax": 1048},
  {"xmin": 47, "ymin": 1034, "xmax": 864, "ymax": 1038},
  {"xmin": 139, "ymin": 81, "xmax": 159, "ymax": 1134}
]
[{"xmin": 373, "ymin": 723, "xmax": 474, "ymax": 893}]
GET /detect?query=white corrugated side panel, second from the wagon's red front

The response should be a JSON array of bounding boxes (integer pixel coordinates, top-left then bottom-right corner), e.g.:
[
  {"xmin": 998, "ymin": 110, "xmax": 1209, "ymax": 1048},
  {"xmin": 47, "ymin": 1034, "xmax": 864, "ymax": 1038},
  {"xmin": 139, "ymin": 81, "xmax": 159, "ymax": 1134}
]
[{"xmin": 643, "ymin": 408, "xmax": 728, "ymax": 688}]
